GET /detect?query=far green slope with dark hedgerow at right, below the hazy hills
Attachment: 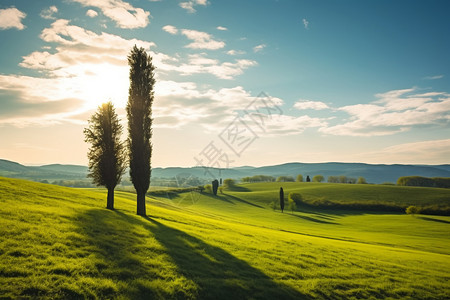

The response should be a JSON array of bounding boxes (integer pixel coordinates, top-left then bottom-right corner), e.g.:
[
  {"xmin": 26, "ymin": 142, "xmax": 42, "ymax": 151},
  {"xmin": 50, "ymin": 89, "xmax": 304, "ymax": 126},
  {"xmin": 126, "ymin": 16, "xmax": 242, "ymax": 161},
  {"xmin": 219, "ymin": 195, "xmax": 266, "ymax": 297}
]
[{"xmin": 234, "ymin": 182, "xmax": 450, "ymax": 215}]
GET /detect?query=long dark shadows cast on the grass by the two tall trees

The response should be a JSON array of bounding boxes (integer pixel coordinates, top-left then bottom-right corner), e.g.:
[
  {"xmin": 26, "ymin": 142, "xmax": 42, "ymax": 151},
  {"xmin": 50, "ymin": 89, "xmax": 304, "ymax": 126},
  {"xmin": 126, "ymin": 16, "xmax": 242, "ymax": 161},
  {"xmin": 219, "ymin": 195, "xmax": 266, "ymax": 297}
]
[{"xmin": 77, "ymin": 209, "xmax": 311, "ymax": 299}]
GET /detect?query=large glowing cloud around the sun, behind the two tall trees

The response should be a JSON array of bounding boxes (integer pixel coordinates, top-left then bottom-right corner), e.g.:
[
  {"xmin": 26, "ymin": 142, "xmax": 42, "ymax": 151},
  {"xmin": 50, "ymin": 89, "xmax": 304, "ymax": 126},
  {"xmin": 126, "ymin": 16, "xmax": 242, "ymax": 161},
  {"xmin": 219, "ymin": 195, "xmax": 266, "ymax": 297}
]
[{"xmin": 0, "ymin": 20, "xmax": 156, "ymax": 126}]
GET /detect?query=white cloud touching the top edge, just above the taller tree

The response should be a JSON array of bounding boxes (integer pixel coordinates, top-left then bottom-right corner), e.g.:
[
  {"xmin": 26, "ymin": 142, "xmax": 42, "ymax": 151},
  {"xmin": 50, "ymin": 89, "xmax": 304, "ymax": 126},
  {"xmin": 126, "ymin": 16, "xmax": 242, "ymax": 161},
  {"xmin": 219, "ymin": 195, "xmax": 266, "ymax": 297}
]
[{"xmin": 71, "ymin": 0, "xmax": 150, "ymax": 29}]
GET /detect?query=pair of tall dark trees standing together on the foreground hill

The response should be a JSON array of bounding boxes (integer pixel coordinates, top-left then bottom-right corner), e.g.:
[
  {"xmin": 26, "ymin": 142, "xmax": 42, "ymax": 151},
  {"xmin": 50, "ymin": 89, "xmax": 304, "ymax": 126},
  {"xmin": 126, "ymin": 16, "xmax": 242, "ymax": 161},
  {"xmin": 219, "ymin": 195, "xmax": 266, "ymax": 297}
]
[{"xmin": 84, "ymin": 45, "xmax": 155, "ymax": 216}]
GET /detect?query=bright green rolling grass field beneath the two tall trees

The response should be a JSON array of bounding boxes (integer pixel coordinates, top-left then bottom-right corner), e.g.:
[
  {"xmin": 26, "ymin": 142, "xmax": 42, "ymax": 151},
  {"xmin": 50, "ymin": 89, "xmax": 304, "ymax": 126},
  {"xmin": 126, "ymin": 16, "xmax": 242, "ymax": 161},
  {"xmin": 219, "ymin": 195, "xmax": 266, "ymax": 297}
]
[{"xmin": 0, "ymin": 178, "xmax": 450, "ymax": 299}]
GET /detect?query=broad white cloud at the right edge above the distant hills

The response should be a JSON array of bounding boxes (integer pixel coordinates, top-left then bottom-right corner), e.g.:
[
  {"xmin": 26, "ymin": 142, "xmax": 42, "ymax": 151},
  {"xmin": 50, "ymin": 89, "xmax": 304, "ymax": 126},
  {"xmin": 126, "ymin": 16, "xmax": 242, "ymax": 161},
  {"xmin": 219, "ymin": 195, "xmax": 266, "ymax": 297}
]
[{"xmin": 320, "ymin": 89, "xmax": 450, "ymax": 136}]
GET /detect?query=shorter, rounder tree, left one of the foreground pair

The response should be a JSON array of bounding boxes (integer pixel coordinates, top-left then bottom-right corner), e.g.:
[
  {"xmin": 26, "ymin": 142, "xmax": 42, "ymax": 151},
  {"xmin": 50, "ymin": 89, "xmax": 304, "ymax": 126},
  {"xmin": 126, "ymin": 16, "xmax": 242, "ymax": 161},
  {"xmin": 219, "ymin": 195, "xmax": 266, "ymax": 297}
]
[{"xmin": 84, "ymin": 102, "xmax": 126, "ymax": 209}]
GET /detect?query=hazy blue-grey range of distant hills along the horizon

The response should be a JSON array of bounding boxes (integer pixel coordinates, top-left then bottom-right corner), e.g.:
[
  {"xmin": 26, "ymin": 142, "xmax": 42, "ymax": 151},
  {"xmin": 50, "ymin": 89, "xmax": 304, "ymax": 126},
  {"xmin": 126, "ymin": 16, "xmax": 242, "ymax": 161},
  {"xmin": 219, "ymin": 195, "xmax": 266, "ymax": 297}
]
[{"xmin": 0, "ymin": 159, "xmax": 450, "ymax": 183}]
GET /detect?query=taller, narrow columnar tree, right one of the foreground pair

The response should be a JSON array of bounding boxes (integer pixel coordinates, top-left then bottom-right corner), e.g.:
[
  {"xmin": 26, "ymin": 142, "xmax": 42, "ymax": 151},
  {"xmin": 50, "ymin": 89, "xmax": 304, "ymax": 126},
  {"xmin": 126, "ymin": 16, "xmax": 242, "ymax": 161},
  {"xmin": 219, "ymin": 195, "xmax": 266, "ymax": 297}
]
[{"xmin": 127, "ymin": 45, "xmax": 155, "ymax": 216}]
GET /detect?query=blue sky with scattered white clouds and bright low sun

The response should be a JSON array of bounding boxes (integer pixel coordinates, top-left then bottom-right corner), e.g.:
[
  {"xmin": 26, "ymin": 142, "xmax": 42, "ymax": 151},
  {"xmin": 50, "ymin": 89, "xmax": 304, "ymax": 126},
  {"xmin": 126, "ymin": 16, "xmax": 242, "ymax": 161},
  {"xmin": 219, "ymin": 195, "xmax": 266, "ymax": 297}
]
[{"xmin": 0, "ymin": 0, "xmax": 450, "ymax": 168}]
